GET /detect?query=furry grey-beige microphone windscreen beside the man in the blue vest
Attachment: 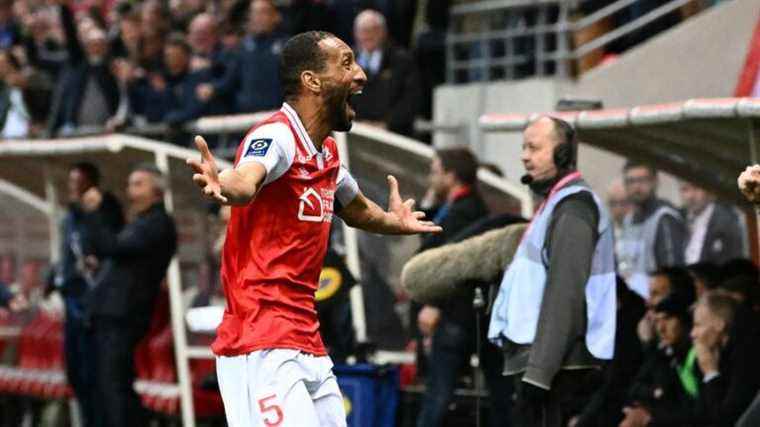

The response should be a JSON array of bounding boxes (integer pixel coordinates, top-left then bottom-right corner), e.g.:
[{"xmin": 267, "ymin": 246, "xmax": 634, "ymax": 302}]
[{"xmin": 401, "ymin": 224, "xmax": 527, "ymax": 304}]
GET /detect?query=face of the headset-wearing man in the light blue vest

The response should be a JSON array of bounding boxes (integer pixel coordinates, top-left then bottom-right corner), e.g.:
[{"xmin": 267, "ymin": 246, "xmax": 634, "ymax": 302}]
[{"xmin": 520, "ymin": 117, "xmax": 558, "ymax": 181}]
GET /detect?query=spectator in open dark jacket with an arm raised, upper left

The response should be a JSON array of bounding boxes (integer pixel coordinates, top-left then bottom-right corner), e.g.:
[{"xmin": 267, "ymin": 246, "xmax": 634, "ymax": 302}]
[{"xmin": 53, "ymin": 0, "xmax": 119, "ymax": 135}]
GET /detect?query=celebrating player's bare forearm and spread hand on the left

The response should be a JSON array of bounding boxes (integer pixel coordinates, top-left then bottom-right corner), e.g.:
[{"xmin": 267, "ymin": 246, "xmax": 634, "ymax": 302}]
[{"xmin": 187, "ymin": 136, "xmax": 267, "ymax": 205}]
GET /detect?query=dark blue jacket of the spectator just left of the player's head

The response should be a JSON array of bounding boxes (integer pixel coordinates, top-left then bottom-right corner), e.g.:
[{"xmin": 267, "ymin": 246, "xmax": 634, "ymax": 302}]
[{"xmin": 214, "ymin": 34, "xmax": 287, "ymax": 113}]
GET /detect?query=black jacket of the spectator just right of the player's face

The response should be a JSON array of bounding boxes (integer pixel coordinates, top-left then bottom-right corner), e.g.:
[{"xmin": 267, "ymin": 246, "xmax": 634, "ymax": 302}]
[{"xmin": 351, "ymin": 48, "xmax": 421, "ymax": 135}]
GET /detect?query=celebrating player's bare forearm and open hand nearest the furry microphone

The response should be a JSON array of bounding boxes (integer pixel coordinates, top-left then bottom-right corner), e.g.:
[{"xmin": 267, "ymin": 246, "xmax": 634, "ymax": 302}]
[{"xmin": 339, "ymin": 175, "xmax": 443, "ymax": 234}]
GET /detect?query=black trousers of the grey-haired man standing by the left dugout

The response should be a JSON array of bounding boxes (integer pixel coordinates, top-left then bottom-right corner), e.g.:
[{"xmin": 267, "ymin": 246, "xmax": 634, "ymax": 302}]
[{"xmin": 92, "ymin": 316, "xmax": 147, "ymax": 427}]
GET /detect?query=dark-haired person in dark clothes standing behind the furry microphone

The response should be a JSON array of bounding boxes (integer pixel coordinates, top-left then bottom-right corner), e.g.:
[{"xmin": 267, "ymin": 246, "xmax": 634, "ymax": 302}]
[{"xmin": 417, "ymin": 148, "xmax": 488, "ymax": 427}]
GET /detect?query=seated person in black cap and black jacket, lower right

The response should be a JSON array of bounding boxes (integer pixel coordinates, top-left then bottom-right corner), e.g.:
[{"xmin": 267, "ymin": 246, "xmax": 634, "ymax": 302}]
[{"xmin": 620, "ymin": 291, "xmax": 701, "ymax": 427}]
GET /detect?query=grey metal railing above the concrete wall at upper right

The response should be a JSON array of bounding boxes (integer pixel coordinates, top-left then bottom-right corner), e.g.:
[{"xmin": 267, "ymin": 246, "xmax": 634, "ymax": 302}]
[{"xmin": 446, "ymin": 0, "xmax": 709, "ymax": 83}]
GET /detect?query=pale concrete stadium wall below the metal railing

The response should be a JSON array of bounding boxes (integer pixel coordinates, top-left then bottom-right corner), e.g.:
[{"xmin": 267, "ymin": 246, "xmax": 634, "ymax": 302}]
[{"xmin": 434, "ymin": 0, "xmax": 760, "ymax": 203}]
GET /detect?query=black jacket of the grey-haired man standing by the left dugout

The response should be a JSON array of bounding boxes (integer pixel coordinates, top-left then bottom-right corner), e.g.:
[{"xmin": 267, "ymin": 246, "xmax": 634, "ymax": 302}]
[{"xmin": 84, "ymin": 203, "xmax": 177, "ymax": 320}]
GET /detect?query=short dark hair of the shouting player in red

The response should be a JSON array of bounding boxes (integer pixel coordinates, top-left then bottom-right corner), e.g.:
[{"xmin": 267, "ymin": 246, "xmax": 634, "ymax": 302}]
[{"xmin": 280, "ymin": 31, "xmax": 335, "ymax": 101}]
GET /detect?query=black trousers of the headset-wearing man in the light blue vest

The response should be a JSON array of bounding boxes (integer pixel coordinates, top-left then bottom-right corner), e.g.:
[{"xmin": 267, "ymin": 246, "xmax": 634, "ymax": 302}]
[{"xmin": 512, "ymin": 369, "xmax": 589, "ymax": 427}]
